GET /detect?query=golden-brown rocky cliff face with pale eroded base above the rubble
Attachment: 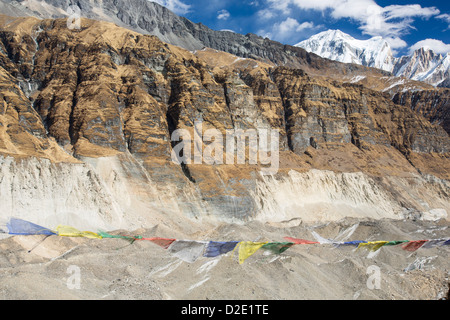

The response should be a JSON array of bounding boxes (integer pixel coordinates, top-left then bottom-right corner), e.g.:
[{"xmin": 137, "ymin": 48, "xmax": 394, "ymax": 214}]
[{"xmin": 0, "ymin": 17, "xmax": 450, "ymax": 228}]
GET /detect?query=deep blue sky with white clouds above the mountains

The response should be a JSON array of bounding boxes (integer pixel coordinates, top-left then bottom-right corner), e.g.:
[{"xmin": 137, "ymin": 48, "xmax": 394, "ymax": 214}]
[{"xmin": 153, "ymin": 0, "xmax": 450, "ymax": 55}]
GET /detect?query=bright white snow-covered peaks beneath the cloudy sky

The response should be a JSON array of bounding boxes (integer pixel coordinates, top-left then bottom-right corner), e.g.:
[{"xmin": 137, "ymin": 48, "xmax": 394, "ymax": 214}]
[{"xmin": 295, "ymin": 30, "xmax": 450, "ymax": 86}]
